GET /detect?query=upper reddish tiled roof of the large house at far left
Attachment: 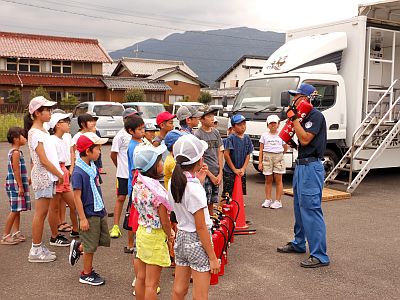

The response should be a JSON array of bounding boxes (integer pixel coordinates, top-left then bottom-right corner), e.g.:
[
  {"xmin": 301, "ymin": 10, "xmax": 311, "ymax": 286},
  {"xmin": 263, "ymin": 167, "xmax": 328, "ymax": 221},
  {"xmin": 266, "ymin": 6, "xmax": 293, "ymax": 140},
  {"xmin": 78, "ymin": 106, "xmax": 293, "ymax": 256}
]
[{"xmin": 0, "ymin": 32, "xmax": 112, "ymax": 63}]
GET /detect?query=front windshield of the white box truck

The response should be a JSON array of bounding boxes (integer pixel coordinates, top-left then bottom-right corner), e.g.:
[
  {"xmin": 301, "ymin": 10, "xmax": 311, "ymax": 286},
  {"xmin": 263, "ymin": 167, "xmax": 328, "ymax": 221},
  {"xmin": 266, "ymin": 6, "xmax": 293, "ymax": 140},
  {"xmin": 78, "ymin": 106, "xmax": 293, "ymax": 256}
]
[{"xmin": 232, "ymin": 77, "xmax": 299, "ymax": 111}]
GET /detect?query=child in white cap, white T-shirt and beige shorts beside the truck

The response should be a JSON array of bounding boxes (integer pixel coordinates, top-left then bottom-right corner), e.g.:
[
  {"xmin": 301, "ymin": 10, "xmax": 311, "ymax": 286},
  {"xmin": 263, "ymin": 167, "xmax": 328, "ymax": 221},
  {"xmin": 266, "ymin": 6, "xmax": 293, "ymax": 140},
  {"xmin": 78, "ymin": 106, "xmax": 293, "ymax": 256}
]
[{"xmin": 258, "ymin": 115, "xmax": 287, "ymax": 209}]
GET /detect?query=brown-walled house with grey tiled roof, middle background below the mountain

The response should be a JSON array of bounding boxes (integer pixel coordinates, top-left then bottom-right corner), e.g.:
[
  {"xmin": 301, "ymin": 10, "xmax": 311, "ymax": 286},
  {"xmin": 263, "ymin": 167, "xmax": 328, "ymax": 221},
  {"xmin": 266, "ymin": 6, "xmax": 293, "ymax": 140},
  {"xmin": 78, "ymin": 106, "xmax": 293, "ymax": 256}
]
[{"xmin": 111, "ymin": 57, "xmax": 207, "ymax": 104}]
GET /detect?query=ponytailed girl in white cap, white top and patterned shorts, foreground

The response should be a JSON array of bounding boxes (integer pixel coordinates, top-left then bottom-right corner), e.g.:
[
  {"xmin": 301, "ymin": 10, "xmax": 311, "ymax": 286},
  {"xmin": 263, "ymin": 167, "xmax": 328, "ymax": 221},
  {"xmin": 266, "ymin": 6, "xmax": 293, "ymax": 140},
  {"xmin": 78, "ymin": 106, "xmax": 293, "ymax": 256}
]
[{"xmin": 168, "ymin": 134, "xmax": 220, "ymax": 299}]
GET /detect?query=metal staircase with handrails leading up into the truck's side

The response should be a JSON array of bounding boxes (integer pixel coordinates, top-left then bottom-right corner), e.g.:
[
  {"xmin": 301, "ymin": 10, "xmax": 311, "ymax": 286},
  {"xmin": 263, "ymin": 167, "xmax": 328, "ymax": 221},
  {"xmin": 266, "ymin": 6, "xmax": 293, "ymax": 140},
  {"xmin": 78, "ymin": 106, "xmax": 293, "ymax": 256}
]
[{"xmin": 325, "ymin": 79, "xmax": 400, "ymax": 193}]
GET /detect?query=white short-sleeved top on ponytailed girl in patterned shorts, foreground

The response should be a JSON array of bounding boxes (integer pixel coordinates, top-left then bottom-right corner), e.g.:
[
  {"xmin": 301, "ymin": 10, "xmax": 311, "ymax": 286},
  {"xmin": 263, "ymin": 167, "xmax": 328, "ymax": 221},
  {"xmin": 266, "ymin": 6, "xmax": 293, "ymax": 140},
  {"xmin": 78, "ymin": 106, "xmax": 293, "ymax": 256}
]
[{"xmin": 168, "ymin": 177, "xmax": 212, "ymax": 232}]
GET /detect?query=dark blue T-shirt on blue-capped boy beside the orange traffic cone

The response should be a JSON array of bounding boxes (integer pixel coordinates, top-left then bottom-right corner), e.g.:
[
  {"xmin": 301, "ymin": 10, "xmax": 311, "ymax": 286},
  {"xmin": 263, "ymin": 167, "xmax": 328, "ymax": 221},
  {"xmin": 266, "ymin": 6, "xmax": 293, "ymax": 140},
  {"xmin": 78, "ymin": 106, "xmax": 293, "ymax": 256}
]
[{"xmin": 224, "ymin": 134, "xmax": 253, "ymax": 173}]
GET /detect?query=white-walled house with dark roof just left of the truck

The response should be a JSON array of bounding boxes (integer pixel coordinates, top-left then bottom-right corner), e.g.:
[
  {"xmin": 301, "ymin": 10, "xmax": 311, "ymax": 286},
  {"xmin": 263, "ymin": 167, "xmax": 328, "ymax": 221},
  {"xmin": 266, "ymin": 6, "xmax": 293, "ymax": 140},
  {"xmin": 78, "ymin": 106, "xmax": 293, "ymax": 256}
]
[{"xmin": 216, "ymin": 55, "xmax": 268, "ymax": 89}]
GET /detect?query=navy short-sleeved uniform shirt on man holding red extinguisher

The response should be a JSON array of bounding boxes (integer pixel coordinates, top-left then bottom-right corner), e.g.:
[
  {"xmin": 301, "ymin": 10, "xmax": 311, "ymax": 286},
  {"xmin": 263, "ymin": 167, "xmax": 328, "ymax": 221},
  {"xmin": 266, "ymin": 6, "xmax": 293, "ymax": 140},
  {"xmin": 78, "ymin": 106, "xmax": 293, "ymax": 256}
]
[{"xmin": 298, "ymin": 107, "xmax": 327, "ymax": 158}]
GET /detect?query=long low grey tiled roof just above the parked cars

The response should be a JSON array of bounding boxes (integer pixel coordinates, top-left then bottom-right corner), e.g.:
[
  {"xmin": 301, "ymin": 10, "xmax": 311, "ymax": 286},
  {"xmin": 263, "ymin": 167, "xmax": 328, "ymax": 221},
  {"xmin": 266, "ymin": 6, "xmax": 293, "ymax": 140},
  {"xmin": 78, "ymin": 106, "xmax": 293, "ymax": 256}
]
[{"xmin": 103, "ymin": 77, "xmax": 171, "ymax": 91}]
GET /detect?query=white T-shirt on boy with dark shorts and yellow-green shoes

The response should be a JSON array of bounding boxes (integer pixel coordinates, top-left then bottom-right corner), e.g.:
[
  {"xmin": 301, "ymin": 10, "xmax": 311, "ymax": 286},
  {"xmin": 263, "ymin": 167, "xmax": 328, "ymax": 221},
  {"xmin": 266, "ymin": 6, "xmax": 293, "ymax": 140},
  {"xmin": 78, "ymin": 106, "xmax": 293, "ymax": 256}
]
[{"xmin": 111, "ymin": 128, "xmax": 132, "ymax": 179}]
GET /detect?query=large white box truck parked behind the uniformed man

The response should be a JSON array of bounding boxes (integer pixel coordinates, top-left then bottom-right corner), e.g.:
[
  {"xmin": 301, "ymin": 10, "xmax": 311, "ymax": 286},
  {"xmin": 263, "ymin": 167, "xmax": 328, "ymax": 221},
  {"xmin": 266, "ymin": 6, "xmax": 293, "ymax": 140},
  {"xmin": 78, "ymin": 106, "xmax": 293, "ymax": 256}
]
[{"xmin": 232, "ymin": 1, "xmax": 400, "ymax": 191}]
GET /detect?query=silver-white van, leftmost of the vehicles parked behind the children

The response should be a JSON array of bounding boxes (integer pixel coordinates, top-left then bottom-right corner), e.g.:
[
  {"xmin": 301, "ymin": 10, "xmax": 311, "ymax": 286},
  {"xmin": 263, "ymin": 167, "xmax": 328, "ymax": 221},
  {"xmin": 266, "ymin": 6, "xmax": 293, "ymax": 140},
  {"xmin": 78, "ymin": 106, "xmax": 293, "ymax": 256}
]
[{"xmin": 71, "ymin": 101, "xmax": 125, "ymax": 139}]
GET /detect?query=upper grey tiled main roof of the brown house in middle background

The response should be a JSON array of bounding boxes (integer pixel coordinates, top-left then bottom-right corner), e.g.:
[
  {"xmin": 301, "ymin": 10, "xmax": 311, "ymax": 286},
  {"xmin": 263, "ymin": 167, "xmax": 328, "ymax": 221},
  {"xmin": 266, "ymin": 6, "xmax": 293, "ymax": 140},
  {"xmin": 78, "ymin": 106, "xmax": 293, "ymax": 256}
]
[{"xmin": 113, "ymin": 57, "xmax": 198, "ymax": 78}]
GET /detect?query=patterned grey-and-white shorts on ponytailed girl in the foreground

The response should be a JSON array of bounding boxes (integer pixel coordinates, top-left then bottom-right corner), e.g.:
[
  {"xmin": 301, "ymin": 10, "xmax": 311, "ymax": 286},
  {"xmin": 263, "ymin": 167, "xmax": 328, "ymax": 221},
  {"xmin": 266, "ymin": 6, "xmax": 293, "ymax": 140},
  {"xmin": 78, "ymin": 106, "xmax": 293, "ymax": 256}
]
[{"xmin": 174, "ymin": 230, "xmax": 211, "ymax": 272}]
